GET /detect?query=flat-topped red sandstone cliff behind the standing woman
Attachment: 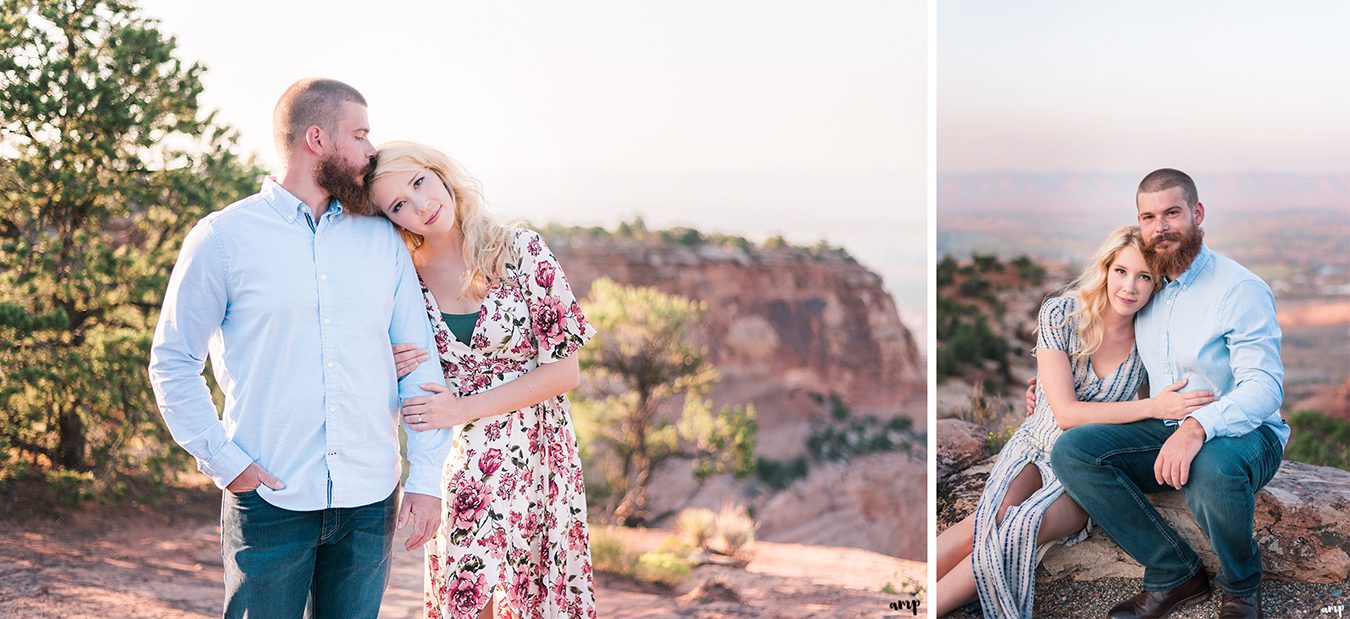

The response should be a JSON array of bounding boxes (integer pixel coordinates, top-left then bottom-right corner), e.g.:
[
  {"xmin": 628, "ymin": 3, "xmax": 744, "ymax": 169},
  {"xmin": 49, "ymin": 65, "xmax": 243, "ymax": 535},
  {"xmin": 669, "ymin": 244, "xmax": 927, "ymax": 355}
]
[{"xmin": 549, "ymin": 235, "xmax": 925, "ymax": 428}]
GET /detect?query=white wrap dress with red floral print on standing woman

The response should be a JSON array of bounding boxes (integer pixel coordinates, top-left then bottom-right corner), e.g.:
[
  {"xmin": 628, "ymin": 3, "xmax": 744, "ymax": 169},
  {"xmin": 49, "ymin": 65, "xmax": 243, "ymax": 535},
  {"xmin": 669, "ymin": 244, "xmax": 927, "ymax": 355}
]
[{"xmin": 423, "ymin": 229, "xmax": 595, "ymax": 619}]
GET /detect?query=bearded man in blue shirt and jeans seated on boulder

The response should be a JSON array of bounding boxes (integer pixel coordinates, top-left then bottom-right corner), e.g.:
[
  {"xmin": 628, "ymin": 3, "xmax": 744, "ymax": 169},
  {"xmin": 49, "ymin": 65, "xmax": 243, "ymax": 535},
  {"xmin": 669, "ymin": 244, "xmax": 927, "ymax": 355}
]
[{"xmin": 1050, "ymin": 169, "xmax": 1289, "ymax": 619}]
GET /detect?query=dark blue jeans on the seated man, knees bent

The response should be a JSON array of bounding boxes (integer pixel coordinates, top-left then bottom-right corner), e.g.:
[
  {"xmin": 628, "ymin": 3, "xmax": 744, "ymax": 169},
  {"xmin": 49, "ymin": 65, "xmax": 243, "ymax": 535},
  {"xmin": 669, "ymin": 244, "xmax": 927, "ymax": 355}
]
[{"xmin": 1050, "ymin": 419, "xmax": 1284, "ymax": 596}]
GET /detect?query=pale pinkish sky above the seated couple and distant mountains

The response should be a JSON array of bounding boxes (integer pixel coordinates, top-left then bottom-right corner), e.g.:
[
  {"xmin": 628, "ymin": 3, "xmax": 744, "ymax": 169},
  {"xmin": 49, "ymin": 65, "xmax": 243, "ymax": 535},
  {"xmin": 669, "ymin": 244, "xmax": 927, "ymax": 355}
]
[{"xmin": 936, "ymin": 0, "xmax": 1350, "ymax": 173}]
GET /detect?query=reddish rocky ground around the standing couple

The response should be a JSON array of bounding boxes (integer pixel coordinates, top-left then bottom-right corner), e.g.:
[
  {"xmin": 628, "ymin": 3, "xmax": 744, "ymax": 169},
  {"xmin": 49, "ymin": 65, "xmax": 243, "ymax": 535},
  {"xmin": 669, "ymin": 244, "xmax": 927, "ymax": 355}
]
[{"xmin": 0, "ymin": 495, "xmax": 927, "ymax": 619}]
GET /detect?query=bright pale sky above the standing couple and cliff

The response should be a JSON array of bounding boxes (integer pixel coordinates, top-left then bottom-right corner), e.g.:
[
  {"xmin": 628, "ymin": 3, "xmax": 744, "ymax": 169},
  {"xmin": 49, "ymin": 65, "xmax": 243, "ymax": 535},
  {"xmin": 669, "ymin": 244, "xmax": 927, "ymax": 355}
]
[{"xmin": 142, "ymin": 0, "xmax": 927, "ymax": 320}]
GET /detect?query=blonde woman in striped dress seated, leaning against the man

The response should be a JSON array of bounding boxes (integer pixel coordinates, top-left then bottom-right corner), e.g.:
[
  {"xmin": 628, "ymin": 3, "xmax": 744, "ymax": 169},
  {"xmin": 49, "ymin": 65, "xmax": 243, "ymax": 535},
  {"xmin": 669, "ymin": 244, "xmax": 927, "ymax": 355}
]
[{"xmin": 937, "ymin": 225, "xmax": 1214, "ymax": 618}]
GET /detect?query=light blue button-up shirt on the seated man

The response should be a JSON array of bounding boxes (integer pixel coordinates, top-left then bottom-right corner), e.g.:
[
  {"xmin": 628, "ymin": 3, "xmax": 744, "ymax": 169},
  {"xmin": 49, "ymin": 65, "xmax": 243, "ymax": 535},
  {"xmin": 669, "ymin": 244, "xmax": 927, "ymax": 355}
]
[{"xmin": 1134, "ymin": 245, "xmax": 1289, "ymax": 445}]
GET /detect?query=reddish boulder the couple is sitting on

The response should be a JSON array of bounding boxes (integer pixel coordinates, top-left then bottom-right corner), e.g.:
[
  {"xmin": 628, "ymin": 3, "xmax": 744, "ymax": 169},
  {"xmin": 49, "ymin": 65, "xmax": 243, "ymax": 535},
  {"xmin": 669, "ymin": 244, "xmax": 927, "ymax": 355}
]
[{"xmin": 938, "ymin": 457, "xmax": 1350, "ymax": 583}]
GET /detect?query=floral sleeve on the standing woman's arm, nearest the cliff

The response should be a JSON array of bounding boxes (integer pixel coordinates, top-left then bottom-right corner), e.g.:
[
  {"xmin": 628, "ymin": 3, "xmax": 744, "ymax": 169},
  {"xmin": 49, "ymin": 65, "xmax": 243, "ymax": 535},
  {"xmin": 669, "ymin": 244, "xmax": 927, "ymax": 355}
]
[{"xmin": 517, "ymin": 231, "xmax": 595, "ymax": 364}]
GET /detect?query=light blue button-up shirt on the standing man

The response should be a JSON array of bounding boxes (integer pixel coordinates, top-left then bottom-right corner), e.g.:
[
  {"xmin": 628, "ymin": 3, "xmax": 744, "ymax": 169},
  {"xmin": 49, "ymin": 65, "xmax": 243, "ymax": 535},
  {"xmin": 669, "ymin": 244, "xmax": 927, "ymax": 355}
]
[{"xmin": 150, "ymin": 178, "xmax": 452, "ymax": 511}]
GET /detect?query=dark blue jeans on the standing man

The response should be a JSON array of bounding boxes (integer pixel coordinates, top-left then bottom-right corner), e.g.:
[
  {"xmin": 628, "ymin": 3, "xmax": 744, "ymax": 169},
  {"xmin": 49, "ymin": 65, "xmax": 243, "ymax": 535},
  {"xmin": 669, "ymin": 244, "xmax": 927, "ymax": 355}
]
[{"xmin": 220, "ymin": 490, "xmax": 398, "ymax": 619}]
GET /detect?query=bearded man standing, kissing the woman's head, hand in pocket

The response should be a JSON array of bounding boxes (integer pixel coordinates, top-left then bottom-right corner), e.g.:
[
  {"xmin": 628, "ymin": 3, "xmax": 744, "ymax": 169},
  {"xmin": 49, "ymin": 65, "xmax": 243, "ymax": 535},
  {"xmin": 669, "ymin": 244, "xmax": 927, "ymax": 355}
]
[{"xmin": 150, "ymin": 78, "xmax": 452, "ymax": 618}]
